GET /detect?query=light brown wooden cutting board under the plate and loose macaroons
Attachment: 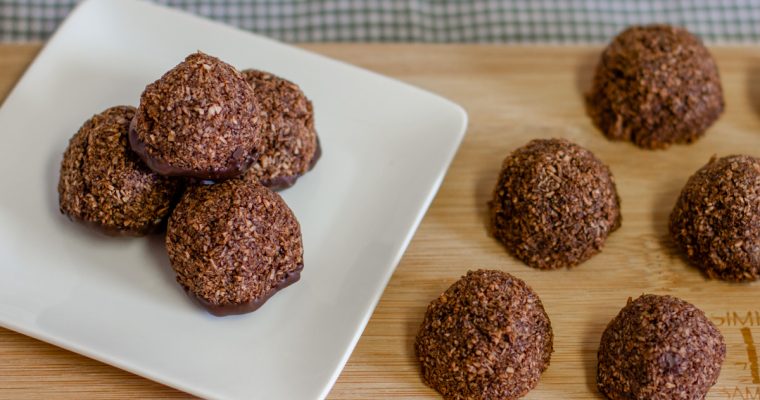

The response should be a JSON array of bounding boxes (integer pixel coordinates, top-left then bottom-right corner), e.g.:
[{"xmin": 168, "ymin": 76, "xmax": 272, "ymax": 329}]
[{"xmin": 0, "ymin": 44, "xmax": 760, "ymax": 400}]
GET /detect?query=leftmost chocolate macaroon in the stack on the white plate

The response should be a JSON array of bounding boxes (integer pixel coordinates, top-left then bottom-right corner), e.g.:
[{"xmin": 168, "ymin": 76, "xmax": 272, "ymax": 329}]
[{"xmin": 58, "ymin": 106, "xmax": 178, "ymax": 236}]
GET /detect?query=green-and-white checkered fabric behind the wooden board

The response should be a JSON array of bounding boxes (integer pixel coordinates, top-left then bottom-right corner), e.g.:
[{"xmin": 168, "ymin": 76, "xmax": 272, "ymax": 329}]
[{"xmin": 0, "ymin": 0, "xmax": 760, "ymax": 43}]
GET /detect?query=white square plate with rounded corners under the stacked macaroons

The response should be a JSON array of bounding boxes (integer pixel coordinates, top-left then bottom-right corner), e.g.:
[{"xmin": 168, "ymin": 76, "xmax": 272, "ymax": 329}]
[{"xmin": 0, "ymin": 0, "xmax": 467, "ymax": 399}]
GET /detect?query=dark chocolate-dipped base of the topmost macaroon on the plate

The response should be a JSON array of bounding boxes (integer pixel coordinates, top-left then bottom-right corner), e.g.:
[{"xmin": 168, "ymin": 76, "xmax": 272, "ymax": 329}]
[{"xmin": 129, "ymin": 119, "xmax": 258, "ymax": 181}]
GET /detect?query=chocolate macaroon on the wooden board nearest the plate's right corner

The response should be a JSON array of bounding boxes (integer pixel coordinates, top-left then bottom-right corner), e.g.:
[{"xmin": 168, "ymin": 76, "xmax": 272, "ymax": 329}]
[{"xmin": 490, "ymin": 139, "xmax": 621, "ymax": 269}]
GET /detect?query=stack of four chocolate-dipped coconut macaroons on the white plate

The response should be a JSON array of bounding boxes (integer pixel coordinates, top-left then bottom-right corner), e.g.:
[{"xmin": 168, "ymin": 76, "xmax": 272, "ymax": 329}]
[{"xmin": 58, "ymin": 52, "xmax": 321, "ymax": 315}]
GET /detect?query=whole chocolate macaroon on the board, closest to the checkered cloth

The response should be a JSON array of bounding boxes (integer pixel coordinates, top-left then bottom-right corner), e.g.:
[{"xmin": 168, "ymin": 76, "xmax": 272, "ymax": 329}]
[{"xmin": 587, "ymin": 25, "xmax": 724, "ymax": 149}]
